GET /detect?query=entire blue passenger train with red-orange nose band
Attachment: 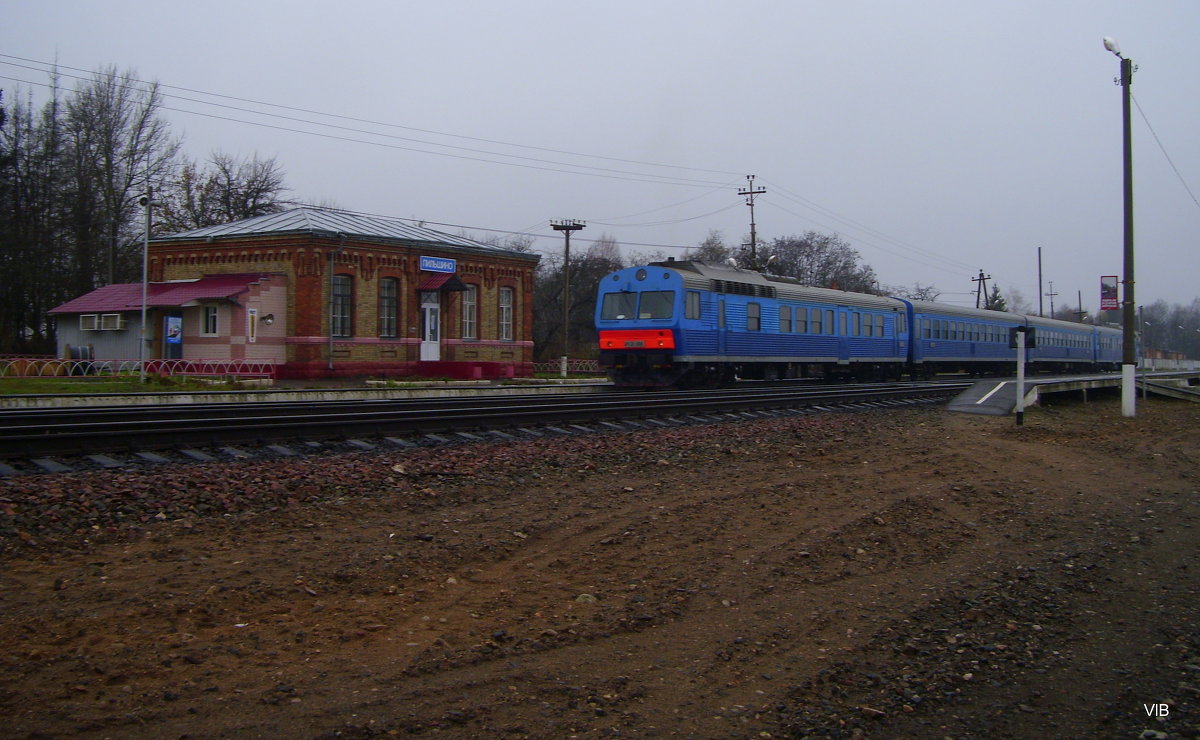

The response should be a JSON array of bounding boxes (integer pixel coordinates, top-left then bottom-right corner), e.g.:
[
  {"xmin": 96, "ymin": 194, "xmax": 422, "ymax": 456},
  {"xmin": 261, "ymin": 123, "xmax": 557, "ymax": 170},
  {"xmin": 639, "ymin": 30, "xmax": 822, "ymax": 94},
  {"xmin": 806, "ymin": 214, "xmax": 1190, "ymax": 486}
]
[{"xmin": 595, "ymin": 259, "xmax": 1122, "ymax": 386}]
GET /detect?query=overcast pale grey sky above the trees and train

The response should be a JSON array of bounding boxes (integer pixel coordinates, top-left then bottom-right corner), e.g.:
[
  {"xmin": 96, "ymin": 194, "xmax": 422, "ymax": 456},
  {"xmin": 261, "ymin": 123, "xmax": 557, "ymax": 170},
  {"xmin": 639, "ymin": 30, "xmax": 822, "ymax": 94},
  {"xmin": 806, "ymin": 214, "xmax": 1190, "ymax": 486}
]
[{"xmin": 0, "ymin": 0, "xmax": 1200, "ymax": 311}]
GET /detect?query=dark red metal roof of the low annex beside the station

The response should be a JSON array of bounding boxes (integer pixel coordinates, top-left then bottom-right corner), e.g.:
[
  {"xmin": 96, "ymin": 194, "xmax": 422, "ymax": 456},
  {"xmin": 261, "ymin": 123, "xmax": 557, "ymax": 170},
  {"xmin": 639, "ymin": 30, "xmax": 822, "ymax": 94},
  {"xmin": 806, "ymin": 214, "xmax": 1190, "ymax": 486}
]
[{"xmin": 50, "ymin": 272, "xmax": 270, "ymax": 313}]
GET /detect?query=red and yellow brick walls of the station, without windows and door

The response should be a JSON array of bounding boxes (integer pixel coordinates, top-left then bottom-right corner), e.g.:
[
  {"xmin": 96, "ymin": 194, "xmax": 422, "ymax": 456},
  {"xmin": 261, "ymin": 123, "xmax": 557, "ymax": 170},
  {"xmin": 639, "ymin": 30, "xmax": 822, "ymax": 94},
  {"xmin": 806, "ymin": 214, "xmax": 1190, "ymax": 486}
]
[{"xmin": 150, "ymin": 211, "xmax": 536, "ymax": 378}]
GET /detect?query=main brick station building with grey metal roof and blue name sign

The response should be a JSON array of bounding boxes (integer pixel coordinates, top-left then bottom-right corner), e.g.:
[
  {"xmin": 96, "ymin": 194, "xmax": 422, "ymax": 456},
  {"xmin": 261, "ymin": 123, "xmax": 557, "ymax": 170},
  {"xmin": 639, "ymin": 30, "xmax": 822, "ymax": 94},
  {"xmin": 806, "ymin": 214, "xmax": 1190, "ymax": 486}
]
[{"xmin": 97, "ymin": 207, "xmax": 539, "ymax": 379}]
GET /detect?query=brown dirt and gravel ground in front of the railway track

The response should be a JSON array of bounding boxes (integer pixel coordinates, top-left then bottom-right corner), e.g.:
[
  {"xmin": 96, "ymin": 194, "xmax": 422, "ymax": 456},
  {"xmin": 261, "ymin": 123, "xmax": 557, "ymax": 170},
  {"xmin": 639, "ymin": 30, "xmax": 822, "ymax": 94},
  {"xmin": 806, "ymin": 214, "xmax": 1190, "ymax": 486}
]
[{"xmin": 0, "ymin": 399, "xmax": 1200, "ymax": 739}]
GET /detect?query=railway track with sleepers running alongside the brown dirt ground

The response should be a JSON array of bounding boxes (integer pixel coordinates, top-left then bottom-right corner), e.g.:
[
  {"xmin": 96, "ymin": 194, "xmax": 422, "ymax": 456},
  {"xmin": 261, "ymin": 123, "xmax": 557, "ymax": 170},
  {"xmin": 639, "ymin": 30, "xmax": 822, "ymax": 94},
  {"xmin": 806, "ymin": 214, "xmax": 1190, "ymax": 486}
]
[{"xmin": 0, "ymin": 381, "xmax": 970, "ymax": 475}]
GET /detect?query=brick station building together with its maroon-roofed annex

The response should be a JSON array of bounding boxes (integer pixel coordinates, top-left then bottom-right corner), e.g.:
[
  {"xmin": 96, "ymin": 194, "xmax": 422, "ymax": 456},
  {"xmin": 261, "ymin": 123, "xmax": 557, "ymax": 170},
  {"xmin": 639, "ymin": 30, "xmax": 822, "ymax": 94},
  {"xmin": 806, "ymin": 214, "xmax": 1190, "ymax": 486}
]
[{"xmin": 52, "ymin": 206, "xmax": 539, "ymax": 379}]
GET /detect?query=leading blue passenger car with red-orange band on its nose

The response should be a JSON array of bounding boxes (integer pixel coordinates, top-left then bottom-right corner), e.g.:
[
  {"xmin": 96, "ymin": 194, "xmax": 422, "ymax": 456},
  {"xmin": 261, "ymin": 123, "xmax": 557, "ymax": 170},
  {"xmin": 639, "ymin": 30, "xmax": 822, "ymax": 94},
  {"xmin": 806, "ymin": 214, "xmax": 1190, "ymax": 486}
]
[{"xmin": 595, "ymin": 260, "xmax": 908, "ymax": 385}]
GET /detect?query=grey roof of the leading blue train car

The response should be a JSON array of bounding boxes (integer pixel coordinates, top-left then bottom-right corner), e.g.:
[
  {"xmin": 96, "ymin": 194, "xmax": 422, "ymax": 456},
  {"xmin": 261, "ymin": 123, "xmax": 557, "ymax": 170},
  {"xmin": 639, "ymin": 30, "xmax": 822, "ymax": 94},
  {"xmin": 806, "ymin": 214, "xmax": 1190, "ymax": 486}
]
[{"xmin": 650, "ymin": 259, "xmax": 904, "ymax": 311}]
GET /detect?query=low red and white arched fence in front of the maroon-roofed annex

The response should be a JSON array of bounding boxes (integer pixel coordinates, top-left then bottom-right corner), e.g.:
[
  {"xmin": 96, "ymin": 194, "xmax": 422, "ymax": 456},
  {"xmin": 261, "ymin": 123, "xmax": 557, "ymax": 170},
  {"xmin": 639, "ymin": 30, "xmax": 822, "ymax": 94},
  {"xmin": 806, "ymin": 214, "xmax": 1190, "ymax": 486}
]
[{"xmin": 0, "ymin": 355, "xmax": 275, "ymax": 378}]
